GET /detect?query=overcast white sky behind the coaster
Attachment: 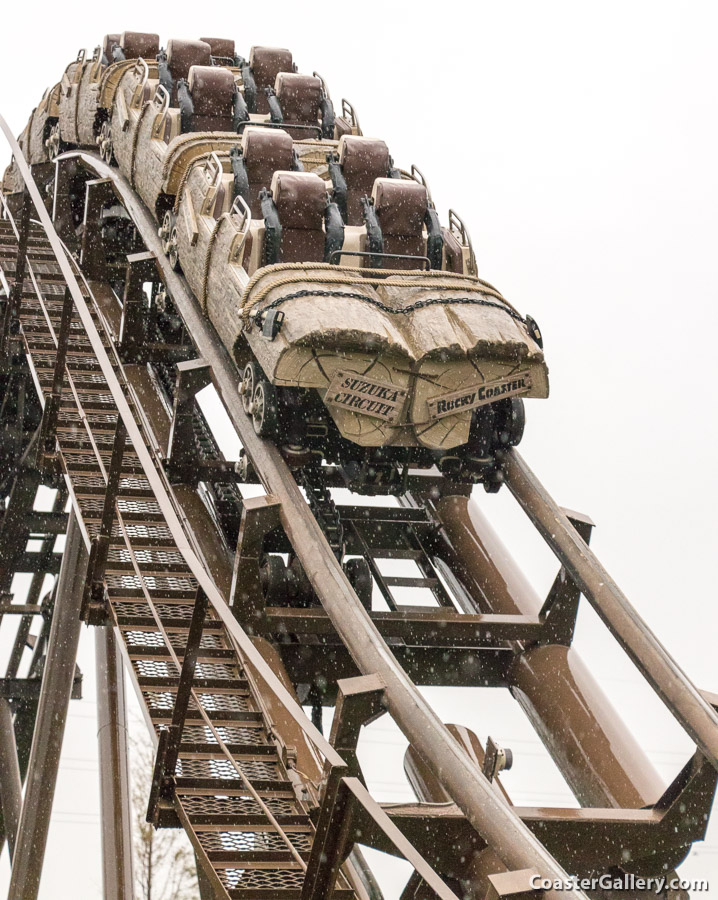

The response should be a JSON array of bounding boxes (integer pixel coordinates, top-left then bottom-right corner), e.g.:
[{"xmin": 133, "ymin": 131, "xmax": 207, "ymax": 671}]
[{"xmin": 0, "ymin": 0, "xmax": 718, "ymax": 900}]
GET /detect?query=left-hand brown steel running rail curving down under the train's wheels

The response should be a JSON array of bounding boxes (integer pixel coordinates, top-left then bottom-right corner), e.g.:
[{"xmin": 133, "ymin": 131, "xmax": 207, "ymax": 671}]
[{"xmin": 53, "ymin": 148, "xmax": 586, "ymax": 900}]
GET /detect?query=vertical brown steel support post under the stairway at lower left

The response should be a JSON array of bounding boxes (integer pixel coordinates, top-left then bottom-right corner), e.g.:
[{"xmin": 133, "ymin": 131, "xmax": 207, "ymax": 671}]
[{"xmin": 95, "ymin": 625, "xmax": 133, "ymax": 900}]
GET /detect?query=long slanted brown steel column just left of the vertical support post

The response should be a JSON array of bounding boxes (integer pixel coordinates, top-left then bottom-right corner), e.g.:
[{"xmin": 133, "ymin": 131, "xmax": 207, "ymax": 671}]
[{"xmin": 8, "ymin": 511, "xmax": 87, "ymax": 900}]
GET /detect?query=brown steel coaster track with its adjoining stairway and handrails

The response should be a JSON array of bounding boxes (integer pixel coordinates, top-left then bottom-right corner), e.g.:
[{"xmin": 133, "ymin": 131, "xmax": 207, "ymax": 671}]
[{"xmin": 0, "ymin": 42, "xmax": 718, "ymax": 900}]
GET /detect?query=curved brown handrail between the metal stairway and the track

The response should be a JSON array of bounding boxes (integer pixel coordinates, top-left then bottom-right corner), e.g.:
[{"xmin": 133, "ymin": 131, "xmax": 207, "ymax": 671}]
[{"xmin": 0, "ymin": 125, "xmax": 484, "ymax": 900}]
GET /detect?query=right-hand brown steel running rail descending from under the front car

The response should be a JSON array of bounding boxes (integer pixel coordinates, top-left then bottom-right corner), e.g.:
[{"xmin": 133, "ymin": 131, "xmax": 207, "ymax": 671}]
[{"xmin": 505, "ymin": 449, "xmax": 718, "ymax": 769}]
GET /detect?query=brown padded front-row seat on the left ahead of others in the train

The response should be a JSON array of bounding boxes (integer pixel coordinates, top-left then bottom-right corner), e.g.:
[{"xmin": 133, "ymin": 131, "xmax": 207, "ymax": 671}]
[{"xmin": 272, "ymin": 172, "xmax": 327, "ymax": 262}]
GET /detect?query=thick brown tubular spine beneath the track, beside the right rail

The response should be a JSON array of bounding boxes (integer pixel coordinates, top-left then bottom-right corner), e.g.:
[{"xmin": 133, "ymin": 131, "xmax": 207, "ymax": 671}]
[{"xmin": 435, "ymin": 496, "xmax": 663, "ymax": 809}]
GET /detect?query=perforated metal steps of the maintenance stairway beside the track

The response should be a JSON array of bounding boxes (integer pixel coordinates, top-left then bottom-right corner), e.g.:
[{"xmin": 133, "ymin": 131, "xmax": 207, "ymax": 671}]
[{"xmin": 8, "ymin": 227, "xmax": 355, "ymax": 900}]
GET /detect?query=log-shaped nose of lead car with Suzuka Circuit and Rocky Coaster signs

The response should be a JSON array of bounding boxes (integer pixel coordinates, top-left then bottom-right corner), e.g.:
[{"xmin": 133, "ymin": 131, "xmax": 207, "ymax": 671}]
[{"xmin": 234, "ymin": 264, "xmax": 549, "ymax": 464}]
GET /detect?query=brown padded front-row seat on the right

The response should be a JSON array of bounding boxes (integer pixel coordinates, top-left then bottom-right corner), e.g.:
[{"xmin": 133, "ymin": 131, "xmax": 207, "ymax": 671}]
[{"xmin": 372, "ymin": 178, "xmax": 429, "ymax": 269}]
